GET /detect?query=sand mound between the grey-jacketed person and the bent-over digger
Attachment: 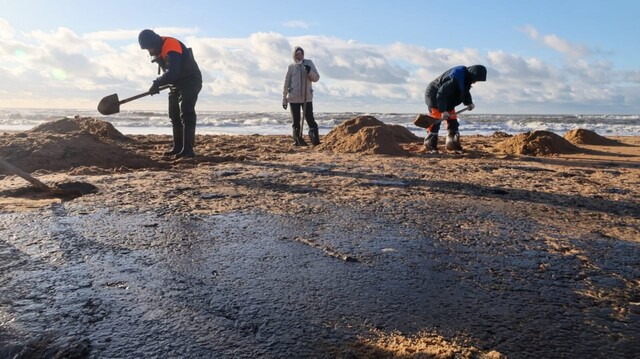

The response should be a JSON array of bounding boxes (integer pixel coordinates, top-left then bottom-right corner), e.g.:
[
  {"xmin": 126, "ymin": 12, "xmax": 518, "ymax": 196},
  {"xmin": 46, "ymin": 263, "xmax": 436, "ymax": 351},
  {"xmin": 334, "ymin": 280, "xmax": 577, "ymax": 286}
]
[{"xmin": 319, "ymin": 116, "xmax": 408, "ymax": 156}]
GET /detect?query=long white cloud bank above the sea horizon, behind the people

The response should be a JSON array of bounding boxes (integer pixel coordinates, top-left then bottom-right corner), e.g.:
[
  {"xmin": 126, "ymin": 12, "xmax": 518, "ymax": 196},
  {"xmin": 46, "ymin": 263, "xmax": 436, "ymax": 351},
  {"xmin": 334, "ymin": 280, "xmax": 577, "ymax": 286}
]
[{"xmin": 0, "ymin": 19, "xmax": 640, "ymax": 113}]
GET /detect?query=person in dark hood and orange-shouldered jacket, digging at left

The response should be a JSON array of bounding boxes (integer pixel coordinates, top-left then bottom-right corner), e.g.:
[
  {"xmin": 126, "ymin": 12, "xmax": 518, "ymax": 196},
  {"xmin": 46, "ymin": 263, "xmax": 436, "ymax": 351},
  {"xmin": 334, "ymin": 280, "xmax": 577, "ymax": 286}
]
[{"xmin": 138, "ymin": 30, "xmax": 202, "ymax": 158}]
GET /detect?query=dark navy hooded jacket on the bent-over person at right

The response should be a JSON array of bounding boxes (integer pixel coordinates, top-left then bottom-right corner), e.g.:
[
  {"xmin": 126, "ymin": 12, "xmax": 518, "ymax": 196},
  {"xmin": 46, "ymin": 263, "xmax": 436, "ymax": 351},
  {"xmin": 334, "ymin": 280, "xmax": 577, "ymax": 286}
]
[{"xmin": 425, "ymin": 65, "xmax": 487, "ymax": 112}]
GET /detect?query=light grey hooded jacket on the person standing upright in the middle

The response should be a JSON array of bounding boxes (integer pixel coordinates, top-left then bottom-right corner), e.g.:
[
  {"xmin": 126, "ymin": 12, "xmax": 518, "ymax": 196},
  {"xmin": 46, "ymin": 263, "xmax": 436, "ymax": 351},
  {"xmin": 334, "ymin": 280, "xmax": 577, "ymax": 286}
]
[{"xmin": 282, "ymin": 46, "xmax": 320, "ymax": 105}]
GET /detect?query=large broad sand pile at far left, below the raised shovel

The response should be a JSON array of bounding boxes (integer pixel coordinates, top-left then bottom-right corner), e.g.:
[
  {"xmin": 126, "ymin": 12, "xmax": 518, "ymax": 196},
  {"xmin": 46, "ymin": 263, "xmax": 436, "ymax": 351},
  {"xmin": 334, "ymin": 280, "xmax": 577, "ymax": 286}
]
[{"xmin": 0, "ymin": 117, "xmax": 158, "ymax": 172}]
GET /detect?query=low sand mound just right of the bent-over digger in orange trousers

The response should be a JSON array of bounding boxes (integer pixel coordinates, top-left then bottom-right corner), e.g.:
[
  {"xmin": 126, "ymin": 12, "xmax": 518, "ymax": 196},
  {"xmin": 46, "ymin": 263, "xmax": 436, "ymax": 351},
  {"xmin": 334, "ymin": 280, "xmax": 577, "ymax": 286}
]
[{"xmin": 496, "ymin": 131, "xmax": 580, "ymax": 156}]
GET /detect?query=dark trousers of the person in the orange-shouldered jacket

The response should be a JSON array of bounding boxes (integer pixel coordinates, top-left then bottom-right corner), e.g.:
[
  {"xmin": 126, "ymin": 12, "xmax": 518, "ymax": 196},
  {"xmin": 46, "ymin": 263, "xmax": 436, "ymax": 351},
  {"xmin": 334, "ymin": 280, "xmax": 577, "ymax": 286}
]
[{"xmin": 169, "ymin": 78, "xmax": 202, "ymax": 127}]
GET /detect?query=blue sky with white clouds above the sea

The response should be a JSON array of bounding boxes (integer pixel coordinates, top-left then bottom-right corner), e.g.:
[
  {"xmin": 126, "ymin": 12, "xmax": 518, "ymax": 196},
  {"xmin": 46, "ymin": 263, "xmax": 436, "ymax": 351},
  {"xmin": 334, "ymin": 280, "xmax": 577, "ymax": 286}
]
[{"xmin": 0, "ymin": 0, "xmax": 640, "ymax": 114}]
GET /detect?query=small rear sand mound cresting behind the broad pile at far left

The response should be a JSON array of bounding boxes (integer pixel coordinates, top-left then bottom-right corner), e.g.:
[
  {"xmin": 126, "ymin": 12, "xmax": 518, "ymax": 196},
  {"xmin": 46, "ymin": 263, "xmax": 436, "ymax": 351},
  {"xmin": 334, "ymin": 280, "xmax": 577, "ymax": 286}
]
[{"xmin": 31, "ymin": 116, "xmax": 129, "ymax": 141}]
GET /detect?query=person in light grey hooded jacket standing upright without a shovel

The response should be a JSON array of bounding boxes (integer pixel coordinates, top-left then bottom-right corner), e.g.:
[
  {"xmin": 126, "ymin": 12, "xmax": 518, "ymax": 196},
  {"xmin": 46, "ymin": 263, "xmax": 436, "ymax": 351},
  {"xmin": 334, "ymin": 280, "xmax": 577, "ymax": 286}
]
[{"xmin": 282, "ymin": 46, "xmax": 320, "ymax": 146}]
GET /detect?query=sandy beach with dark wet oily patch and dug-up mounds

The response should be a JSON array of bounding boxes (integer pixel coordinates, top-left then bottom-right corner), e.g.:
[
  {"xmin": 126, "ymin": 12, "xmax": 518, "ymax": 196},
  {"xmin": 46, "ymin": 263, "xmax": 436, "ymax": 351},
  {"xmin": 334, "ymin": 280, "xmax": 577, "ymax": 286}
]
[{"xmin": 0, "ymin": 117, "xmax": 640, "ymax": 358}]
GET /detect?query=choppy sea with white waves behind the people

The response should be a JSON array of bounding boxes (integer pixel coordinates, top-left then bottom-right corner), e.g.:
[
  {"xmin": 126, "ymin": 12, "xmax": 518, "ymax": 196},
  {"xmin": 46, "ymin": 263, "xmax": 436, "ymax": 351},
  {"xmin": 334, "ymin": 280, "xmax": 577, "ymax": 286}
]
[{"xmin": 0, "ymin": 108, "xmax": 640, "ymax": 136}]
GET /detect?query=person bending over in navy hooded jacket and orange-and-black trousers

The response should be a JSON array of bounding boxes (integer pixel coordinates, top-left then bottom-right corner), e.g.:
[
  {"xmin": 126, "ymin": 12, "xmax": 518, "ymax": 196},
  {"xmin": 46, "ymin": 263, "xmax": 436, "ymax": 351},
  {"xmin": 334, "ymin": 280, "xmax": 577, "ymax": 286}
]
[{"xmin": 424, "ymin": 65, "xmax": 487, "ymax": 153}]
